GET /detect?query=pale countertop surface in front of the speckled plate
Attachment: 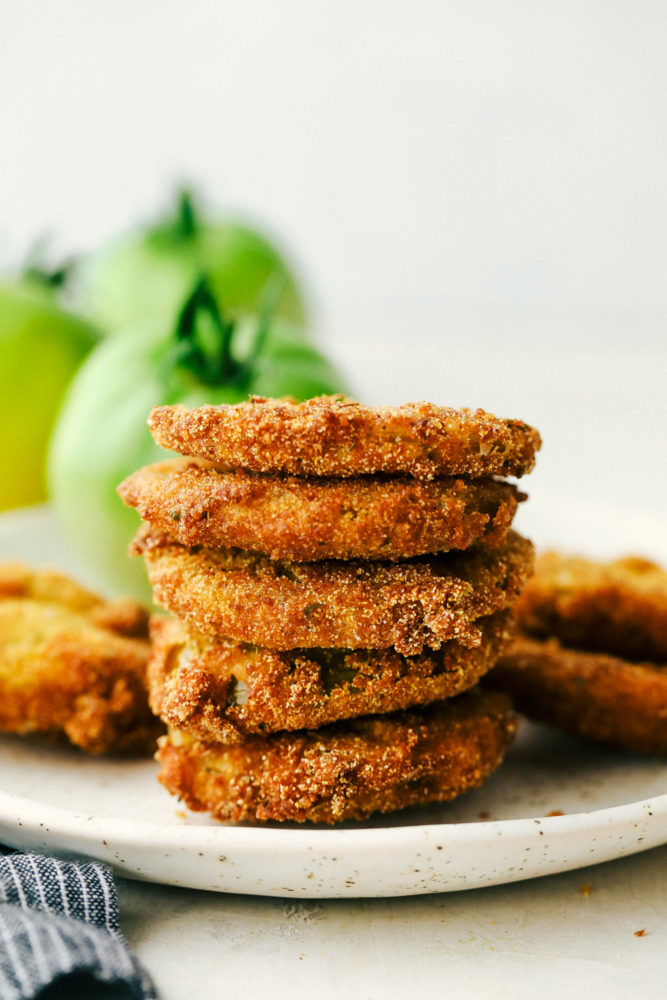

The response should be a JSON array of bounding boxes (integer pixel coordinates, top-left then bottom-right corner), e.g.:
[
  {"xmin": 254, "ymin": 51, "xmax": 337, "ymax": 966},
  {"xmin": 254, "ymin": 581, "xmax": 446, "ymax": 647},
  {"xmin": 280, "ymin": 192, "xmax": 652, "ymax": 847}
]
[{"xmin": 119, "ymin": 847, "xmax": 667, "ymax": 1000}]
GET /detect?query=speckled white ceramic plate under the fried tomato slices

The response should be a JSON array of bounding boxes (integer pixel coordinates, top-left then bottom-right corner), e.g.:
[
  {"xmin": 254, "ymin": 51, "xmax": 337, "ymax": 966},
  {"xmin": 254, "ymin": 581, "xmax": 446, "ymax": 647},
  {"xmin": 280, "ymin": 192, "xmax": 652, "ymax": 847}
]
[{"xmin": 0, "ymin": 496, "xmax": 667, "ymax": 897}]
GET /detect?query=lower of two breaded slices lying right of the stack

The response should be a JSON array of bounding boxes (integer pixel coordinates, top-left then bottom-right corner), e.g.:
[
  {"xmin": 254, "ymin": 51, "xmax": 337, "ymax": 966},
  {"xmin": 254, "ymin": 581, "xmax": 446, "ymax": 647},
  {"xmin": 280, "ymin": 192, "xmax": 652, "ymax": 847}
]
[{"xmin": 485, "ymin": 635, "xmax": 667, "ymax": 754}]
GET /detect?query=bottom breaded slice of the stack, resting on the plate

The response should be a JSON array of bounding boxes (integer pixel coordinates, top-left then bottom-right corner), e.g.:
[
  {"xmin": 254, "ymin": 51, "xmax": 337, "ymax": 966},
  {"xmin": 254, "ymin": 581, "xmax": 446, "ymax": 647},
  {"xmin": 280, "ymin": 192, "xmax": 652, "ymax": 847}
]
[{"xmin": 157, "ymin": 691, "xmax": 516, "ymax": 823}]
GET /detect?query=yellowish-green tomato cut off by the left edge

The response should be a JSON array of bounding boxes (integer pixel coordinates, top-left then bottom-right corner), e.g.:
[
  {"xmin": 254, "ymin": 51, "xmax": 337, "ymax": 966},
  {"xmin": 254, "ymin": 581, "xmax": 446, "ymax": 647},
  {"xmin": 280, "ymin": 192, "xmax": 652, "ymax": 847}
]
[{"xmin": 0, "ymin": 281, "xmax": 98, "ymax": 509}]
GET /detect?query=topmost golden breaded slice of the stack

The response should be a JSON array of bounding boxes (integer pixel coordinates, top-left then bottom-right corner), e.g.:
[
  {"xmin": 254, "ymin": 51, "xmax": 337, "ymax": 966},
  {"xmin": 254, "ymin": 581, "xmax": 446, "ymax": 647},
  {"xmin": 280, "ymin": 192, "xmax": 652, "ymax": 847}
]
[{"xmin": 148, "ymin": 396, "xmax": 541, "ymax": 479}]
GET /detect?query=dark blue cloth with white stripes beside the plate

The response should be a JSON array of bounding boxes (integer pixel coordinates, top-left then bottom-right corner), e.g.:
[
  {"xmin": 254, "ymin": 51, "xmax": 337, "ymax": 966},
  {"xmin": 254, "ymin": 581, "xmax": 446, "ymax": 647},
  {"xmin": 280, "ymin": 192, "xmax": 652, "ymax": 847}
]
[{"xmin": 0, "ymin": 854, "xmax": 157, "ymax": 1000}]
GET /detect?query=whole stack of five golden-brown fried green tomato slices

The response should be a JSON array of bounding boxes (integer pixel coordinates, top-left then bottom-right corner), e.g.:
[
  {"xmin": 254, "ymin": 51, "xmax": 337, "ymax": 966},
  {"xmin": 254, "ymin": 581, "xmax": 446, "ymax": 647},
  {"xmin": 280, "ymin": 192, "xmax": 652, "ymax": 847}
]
[{"xmin": 119, "ymin": 396, "xmax": 540, "ymax": 823}]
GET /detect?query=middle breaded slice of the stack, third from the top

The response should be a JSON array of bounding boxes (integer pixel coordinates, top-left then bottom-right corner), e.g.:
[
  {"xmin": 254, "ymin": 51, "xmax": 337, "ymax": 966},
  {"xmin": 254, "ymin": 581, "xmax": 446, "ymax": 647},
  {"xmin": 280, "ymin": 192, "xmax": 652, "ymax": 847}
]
[{"xmin": 132, "ymin": 526, "xmax": 533, "ymax": 656}]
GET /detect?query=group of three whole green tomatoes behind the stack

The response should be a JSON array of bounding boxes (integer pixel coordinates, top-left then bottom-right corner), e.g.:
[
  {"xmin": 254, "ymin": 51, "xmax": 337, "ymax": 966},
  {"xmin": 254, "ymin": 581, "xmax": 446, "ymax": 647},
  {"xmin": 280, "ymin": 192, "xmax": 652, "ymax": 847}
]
[{"xmin": 0, "ymin": 193, "xmax": 345, "ymax": 597}]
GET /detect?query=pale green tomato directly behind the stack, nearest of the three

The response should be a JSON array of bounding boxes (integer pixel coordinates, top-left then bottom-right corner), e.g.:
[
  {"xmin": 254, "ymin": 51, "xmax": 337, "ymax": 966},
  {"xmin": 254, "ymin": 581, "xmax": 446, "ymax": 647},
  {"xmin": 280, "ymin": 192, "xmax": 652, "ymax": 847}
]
[{"xmin": 49, "ymin": 286, "xmax": 350, "ymax": 600}]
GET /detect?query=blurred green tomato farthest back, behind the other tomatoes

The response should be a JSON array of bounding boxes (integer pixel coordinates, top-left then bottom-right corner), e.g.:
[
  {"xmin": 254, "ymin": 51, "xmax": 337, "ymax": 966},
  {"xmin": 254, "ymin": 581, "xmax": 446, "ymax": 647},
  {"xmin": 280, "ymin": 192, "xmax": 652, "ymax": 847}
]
[{"xmin": 83, "ymin": 194, "xmax": 306, "ymax": 333}]
